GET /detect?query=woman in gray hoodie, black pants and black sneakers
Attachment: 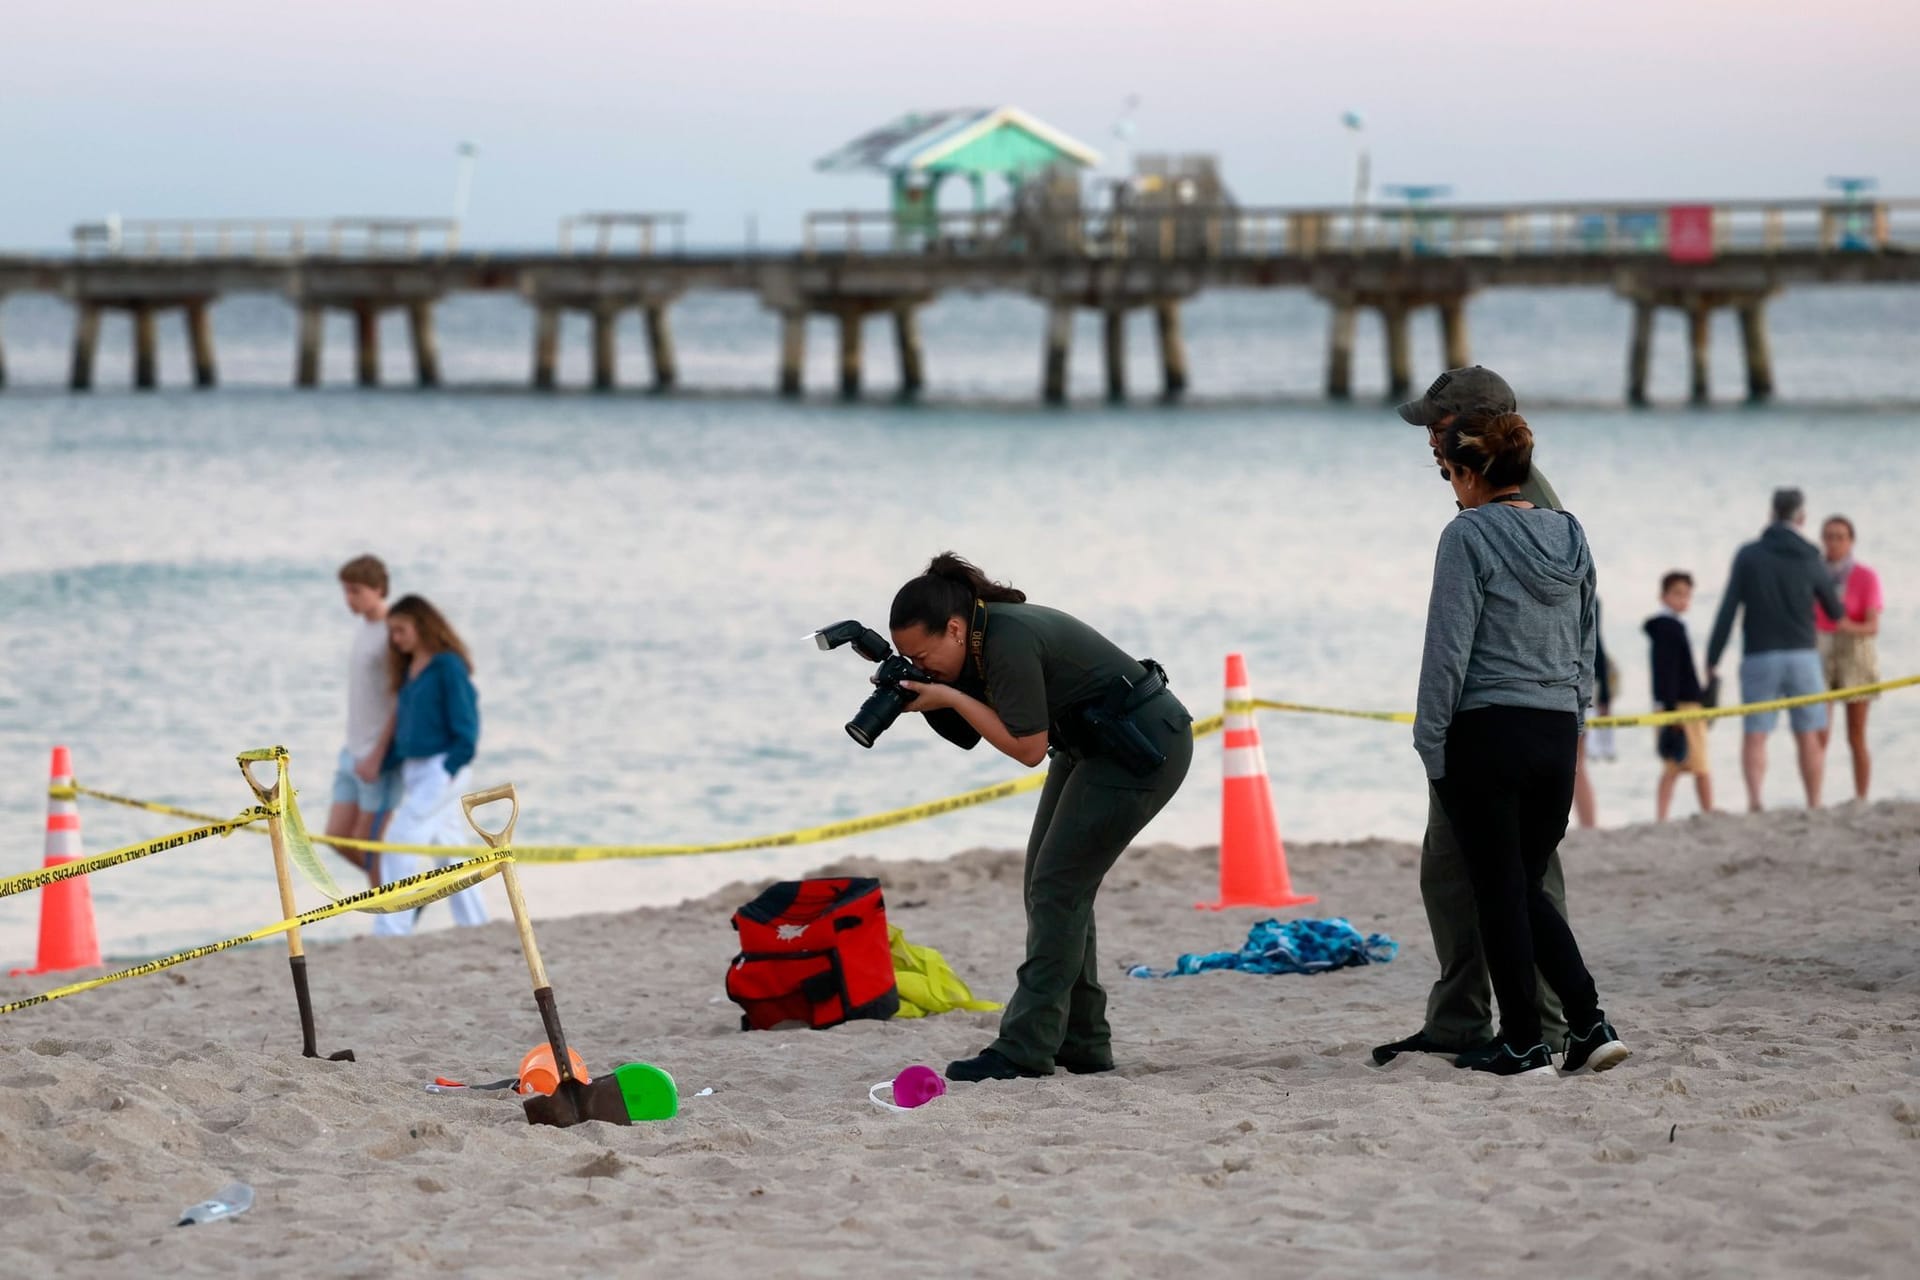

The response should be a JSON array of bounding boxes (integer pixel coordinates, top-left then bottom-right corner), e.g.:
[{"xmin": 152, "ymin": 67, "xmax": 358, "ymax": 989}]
[{"xmin": 1413, "ymin": 411, "xmax": 1626, "ymax": 1075}]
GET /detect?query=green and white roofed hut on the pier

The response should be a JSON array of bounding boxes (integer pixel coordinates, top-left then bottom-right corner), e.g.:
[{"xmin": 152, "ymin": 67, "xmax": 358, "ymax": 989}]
[{"xmin": 814, "ymin": 107, "xmax": 1100, "ymax": 232}]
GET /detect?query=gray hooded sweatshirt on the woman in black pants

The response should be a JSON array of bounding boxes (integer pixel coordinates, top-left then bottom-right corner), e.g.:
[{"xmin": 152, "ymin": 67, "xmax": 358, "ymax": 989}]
[{"xmin": 1413, "ymin": 503, "xmax": 1599, "ymax": 777}]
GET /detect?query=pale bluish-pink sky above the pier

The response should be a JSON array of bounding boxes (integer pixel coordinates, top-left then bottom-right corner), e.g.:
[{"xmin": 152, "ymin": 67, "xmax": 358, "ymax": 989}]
[{"xmin": 0, "ymin": 0, "xmax": 1920, "ymax": 251}]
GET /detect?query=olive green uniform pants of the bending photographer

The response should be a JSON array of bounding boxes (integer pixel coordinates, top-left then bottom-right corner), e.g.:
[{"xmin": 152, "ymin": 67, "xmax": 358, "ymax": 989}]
[{"xmin": 991, "ymin": 693, "xmax": 1182, "ymax": 1073}]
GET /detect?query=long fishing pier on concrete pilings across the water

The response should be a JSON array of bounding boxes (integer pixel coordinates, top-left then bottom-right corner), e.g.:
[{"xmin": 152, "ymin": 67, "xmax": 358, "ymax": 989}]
[{"xmin": 0, "ymin": 200, "xmax": 1920, "ymax": 405}]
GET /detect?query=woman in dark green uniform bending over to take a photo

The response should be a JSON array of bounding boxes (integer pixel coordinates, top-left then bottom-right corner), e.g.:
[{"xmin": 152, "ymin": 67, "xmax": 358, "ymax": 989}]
[{"xmin": 887, "ymin": 553, "xmax": 1192, "ymax": 1080}]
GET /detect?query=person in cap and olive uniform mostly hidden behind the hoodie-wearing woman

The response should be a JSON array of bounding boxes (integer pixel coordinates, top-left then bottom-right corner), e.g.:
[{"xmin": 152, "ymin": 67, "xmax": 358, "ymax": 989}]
[{"xmin": 1373, "ymin": 365, "xmax": 1567, "ymax": 1067}]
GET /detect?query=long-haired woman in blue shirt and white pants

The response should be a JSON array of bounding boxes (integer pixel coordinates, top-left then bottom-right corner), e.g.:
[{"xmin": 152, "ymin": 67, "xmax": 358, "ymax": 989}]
[{"xmin": 372, "ymin": 595, "xmax": 486, "ymax": 935}]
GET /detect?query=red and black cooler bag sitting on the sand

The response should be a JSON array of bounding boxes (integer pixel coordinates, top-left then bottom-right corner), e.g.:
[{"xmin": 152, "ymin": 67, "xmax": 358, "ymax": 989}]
[{"xmin": 726, "ymin": 877, "xmax": 900, "ymax": 1031}]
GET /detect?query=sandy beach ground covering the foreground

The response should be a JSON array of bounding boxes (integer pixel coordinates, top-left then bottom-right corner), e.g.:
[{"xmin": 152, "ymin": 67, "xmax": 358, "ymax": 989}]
[{"xmin": 0, "ymin": 804, "xmax": 1920, "ymax": 1280}]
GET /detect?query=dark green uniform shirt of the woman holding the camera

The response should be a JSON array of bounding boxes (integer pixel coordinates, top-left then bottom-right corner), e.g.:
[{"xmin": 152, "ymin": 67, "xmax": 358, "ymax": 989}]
[{"xmin": 985, "ymin": 604, "xmax": 1146, "ymax": 737}]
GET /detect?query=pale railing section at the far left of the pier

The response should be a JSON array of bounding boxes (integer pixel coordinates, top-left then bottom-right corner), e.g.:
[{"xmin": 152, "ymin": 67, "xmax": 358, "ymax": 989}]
[{"xmin": 73, "ymin": 217, "xmax": 461, "ymax": 259}]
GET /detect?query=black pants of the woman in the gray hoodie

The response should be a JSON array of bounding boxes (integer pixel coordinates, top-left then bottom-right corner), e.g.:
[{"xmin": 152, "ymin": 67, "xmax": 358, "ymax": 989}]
[{"xmin": 1434, "ymin": 706, "xmax": 1599, "ymax": 1050}]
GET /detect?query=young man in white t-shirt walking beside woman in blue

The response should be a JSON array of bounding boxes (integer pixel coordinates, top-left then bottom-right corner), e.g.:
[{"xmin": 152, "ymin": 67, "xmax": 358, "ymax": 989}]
[{"xmin": 326, "ymin": 555, "xmax": 397, "ymax": 887}]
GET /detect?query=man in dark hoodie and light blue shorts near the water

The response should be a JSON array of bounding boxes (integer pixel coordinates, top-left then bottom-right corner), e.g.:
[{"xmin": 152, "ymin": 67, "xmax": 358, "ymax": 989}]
[{"xmin": 1707, "ymin": 489, "xmax": 1847, "ymax": 814}]
